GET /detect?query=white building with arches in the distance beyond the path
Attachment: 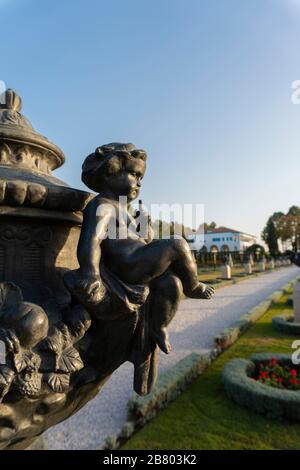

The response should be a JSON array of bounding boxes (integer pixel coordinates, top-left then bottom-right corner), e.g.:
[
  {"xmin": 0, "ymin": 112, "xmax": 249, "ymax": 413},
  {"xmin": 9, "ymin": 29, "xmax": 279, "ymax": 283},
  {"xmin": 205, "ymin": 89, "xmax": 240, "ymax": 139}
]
[{"xmin": 187, "ymin": 227, "xmax": 256, "ymax": 253}]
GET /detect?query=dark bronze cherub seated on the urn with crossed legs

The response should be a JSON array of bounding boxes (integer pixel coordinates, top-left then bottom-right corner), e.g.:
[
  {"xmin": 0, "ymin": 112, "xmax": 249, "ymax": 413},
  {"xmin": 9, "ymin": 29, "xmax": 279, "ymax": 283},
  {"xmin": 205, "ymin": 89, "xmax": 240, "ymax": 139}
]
[{"xmin": 65, "ymin": 143, "xmax": 214, "ymax": 360}]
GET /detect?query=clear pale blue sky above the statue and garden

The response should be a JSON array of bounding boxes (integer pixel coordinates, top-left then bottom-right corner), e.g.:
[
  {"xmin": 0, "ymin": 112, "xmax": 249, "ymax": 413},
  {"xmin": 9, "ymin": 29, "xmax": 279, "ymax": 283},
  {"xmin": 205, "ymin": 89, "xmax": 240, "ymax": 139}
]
[{"xmin": 0, "ymin": 0, "xmax": 300, "ymax": 241}]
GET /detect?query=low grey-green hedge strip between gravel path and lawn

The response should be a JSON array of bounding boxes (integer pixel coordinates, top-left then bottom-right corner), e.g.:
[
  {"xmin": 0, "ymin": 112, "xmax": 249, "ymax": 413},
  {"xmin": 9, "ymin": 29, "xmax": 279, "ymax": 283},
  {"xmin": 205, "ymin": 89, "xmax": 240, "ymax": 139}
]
[{"xmin": 102, "ymin": 277, "xmax": 298, "ymax": 450}]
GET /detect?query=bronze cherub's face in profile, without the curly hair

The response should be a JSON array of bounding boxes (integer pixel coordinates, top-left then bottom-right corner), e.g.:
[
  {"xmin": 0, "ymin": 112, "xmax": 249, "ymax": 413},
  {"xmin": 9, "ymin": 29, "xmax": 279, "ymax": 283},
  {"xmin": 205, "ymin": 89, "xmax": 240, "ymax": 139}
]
[{"xmin": 107, "ymin": 158, "xmax": 146, "ymax": 202}]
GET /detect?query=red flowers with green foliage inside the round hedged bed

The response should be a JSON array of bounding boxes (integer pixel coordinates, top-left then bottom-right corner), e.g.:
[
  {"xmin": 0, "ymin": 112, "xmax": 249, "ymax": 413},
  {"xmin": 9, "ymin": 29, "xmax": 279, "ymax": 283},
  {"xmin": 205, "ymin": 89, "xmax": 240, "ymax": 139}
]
[{"xmin": 253, "ymin": 358, "xmax": 300, "ymax": 390}]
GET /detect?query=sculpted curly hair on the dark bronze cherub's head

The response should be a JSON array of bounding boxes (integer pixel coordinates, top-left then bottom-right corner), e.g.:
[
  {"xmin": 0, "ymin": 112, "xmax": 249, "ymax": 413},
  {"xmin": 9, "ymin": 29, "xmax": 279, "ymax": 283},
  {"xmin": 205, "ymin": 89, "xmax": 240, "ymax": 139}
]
[{"xmin": 81, "ymin": 142, "xmax": 147, "ymax": 192}]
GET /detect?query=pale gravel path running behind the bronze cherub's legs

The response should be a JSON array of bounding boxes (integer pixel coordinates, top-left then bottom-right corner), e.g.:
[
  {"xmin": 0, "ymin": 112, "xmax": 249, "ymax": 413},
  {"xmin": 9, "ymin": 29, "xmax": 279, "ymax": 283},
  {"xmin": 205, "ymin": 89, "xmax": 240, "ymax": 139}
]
[{"xmin": 44, "ymin": 266, "xmax": 300, "ymax": 450}]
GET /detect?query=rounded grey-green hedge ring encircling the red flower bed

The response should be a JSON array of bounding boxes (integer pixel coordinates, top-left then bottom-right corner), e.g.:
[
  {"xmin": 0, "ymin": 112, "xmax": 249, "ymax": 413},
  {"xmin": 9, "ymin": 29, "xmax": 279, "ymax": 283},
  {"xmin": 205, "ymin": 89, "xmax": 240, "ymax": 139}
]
[{"xmin": 222, "ymin": 353, "xmax": 300, "ymax": 421}]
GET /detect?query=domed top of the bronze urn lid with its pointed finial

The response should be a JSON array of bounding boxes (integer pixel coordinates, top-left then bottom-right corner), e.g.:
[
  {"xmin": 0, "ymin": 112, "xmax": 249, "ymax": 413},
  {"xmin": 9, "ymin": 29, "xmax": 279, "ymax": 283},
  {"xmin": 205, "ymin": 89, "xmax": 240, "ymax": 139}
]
[{"xmin": 0, "ymin": 89, "xmax": 65, "ymax": 171}]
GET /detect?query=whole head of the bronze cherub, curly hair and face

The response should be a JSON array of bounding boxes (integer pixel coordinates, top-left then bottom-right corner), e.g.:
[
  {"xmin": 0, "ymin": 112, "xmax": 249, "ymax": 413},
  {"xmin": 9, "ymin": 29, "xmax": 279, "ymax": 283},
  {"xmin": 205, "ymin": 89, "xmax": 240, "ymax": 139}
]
[{"xmin": 82, "ymin": 143, "xmax": 147, "ymax": 201}]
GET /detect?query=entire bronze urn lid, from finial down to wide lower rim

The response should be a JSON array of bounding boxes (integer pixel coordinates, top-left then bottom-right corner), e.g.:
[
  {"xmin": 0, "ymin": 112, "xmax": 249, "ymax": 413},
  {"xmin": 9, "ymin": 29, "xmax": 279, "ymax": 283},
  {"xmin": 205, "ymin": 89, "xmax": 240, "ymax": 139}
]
[{"xmin": 0, "ymin": 89, "xmax": 91, "ymax": 217}]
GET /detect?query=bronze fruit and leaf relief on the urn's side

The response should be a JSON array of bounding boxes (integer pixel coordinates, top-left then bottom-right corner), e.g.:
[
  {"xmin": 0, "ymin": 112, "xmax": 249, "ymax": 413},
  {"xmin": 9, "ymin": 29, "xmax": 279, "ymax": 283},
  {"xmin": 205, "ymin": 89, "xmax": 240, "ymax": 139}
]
[{"xmin": 0, "ymin": 282, "xmax": 91, "ymax": 402}]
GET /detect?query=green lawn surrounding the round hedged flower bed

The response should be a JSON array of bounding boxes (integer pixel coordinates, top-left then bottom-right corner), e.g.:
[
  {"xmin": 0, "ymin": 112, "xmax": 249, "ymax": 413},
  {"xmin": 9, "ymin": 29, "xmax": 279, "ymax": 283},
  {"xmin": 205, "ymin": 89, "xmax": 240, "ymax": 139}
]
[{"xmin": 122, "ymin": 288, "xmax": 300, "ymax": 450}]
